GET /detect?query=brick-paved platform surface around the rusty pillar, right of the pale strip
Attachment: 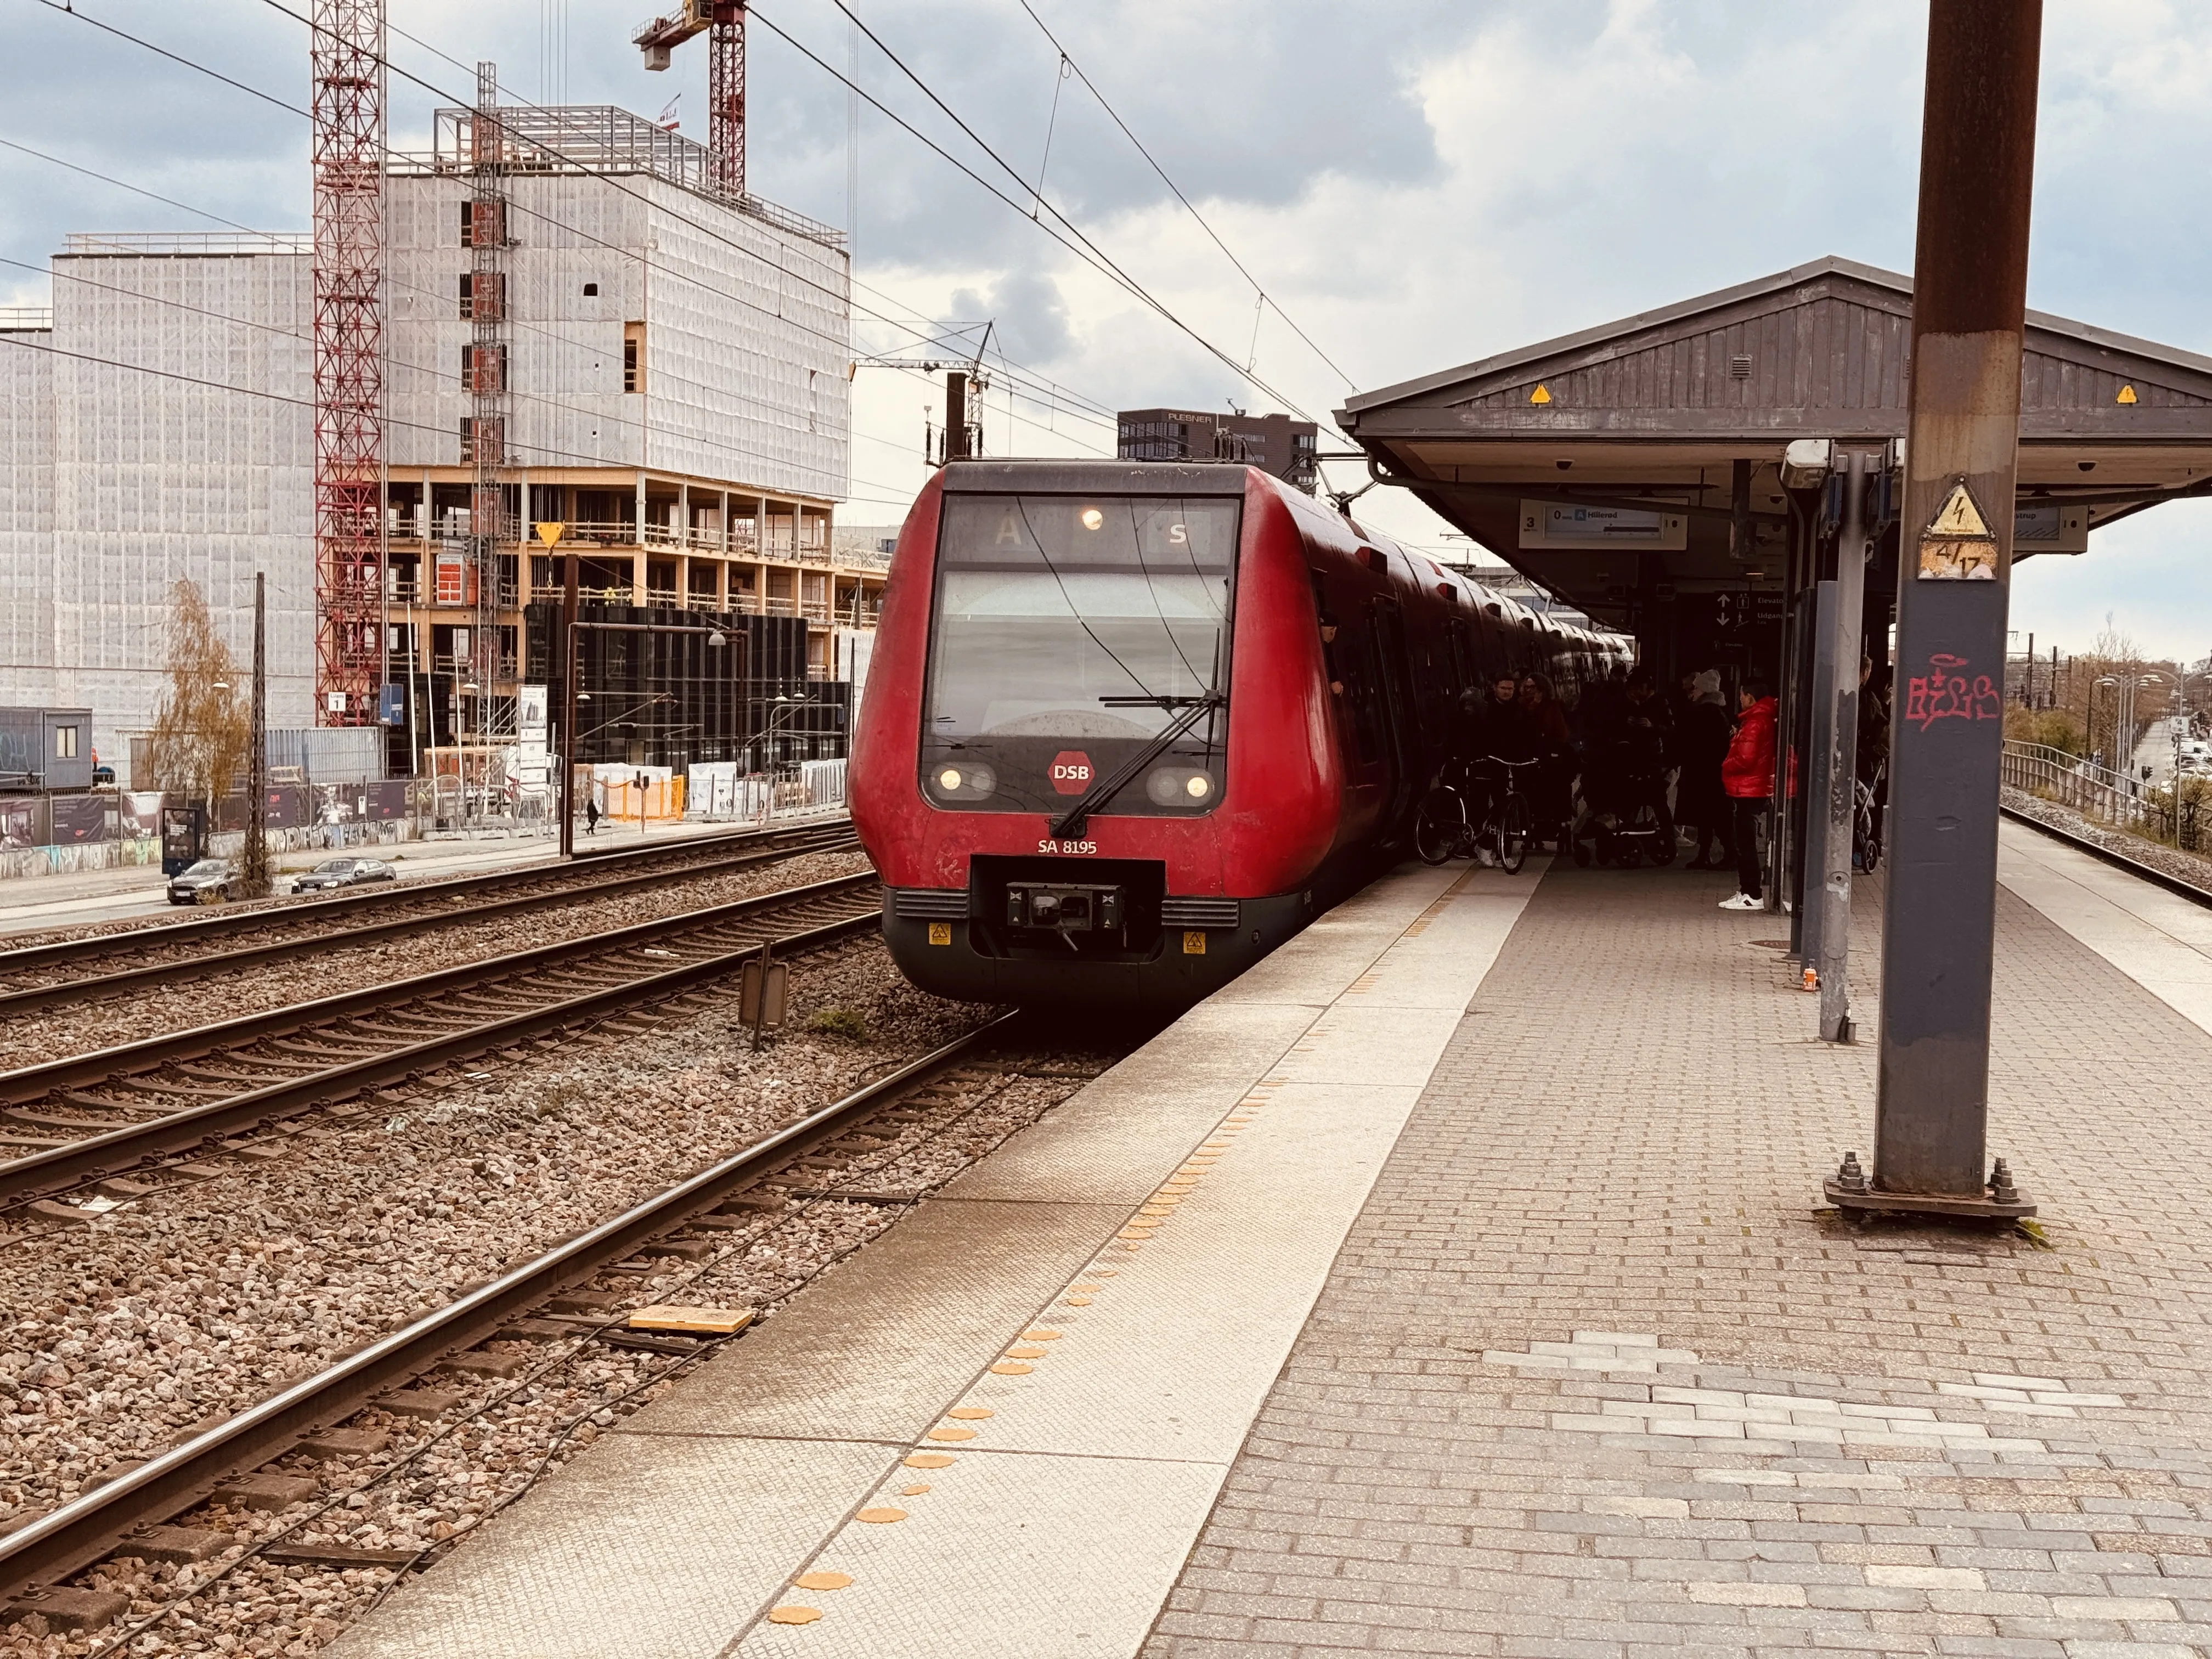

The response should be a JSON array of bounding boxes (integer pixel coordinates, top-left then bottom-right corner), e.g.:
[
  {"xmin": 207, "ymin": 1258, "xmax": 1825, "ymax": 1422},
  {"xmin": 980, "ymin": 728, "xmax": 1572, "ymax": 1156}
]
[{"xmin": 1144, "ymin": 825, "xmax": 2212, "ymax": 1659}]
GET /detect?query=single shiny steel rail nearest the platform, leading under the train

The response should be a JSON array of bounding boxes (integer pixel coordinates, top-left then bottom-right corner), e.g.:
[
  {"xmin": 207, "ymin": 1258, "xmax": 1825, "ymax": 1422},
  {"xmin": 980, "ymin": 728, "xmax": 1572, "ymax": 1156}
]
[{"xmin": 0, "ymin": 1013, "xmax": 1020, "ymax": 1599}]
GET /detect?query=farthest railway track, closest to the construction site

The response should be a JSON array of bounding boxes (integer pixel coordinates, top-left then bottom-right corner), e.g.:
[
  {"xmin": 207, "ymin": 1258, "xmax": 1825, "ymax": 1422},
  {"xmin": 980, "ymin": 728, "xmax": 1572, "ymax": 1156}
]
[{"xmin": 0, "ymin": 821, "xmax": 860, "ymax": 1020}]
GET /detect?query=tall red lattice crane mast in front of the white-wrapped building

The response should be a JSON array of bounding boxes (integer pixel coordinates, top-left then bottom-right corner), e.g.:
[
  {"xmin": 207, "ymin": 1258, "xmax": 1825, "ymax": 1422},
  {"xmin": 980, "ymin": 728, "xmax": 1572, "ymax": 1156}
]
[{"xmin": 309, "ymin": 0, "xmax": 385, "ymax": 725}]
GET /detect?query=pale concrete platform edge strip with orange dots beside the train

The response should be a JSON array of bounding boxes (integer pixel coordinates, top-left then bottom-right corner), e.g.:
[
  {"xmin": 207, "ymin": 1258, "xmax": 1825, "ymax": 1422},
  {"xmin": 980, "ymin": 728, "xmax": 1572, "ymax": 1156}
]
[{"xmin": 338, "ymin": 870, "xmax": 1537, "ymax": 1659}]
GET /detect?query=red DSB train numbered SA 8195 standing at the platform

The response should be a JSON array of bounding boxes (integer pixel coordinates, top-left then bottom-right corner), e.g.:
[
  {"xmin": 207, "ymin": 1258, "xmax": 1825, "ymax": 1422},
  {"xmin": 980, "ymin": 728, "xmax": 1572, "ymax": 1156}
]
[{"xmin": 849, "ymin": 460, "xmax": 1626, "ymax": 1009}]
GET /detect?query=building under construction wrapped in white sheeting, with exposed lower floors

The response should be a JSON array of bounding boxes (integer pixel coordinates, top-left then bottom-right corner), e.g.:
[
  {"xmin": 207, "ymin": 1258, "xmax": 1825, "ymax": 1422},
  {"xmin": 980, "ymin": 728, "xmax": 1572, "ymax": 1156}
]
[{"xmin": 0, "ymin": 91, "xmax": 887, "ymax": 770}]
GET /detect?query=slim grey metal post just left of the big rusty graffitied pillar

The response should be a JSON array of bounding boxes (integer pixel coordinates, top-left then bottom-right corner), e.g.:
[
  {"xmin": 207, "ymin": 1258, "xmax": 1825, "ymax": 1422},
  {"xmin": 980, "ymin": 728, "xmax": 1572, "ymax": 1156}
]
[{"xmin": 1805, "ymin": 452, "xmax": 1880, "ymax": 1042}]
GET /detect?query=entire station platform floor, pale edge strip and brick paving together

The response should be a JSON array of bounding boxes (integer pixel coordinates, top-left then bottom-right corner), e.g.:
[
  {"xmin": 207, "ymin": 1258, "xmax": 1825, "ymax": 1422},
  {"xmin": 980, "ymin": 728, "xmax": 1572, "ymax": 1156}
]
[{"xmin": 334, "ymin": 827, "xmax": 2212, "ymax": 1659}]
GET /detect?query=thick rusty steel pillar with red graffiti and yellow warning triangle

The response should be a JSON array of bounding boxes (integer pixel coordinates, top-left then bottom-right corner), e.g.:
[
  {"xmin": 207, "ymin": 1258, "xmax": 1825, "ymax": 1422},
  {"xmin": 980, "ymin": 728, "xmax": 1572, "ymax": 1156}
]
[{"xmin": 1827, "ymin": 0, "xmax": 2044, "ymax": 1217}]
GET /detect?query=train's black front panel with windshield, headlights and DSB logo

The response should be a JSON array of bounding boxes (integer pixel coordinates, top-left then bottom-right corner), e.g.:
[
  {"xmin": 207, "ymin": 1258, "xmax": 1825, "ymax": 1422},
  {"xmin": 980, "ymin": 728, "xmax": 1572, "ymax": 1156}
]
[{"xmin": 922, "ymin": 495, "xmax": 1241, "ymax": 816}]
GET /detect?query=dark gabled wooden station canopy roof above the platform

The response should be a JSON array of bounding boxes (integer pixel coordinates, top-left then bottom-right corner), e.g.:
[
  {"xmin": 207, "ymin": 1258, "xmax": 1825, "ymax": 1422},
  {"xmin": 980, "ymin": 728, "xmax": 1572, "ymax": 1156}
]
[{"xmin": 1336, "ymin": 257, "xmax": 2212, "ymax": 624}]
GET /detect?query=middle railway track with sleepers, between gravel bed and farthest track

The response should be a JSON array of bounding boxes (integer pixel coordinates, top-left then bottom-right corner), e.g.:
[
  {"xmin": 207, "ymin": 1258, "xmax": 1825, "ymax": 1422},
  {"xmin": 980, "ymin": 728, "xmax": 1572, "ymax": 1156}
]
[{"xmin": 0, "ymin": 876, "xmax": 881, "ymax": 1221}]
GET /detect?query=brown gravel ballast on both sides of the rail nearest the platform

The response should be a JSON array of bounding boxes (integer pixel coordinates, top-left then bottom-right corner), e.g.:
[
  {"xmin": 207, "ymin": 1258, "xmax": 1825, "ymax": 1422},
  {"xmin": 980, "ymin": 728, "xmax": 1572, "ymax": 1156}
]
[{"xmin": 0, "ymin": 940, "xmax": 1124, "ymax": 1657}]
